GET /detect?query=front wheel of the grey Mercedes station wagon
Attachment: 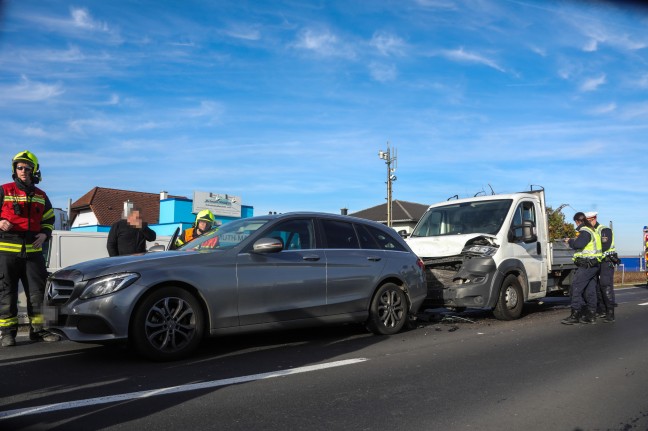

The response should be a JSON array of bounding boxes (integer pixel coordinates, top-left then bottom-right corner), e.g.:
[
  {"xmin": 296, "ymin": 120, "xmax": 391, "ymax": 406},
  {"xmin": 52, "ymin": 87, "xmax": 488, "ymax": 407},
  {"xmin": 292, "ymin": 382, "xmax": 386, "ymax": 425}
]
[{"xmin": 130, "ymin": 287, "xmax": 204, "ymax": 361}]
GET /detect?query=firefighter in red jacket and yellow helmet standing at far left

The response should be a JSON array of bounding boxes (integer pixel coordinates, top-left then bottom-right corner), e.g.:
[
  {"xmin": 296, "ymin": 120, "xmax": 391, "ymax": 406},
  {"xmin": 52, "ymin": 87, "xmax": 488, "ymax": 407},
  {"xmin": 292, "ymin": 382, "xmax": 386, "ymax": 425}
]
[{"xmin": 0, "ymin": 151, "xmax": 60, "ymax": 347}]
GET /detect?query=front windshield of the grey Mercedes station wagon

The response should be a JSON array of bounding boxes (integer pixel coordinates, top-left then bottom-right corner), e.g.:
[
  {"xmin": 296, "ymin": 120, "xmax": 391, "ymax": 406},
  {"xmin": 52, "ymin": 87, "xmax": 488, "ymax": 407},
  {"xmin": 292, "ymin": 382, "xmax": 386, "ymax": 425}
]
[{"xmin": 179, "ymin": 218, "xmax": 270, "ymax": 251}]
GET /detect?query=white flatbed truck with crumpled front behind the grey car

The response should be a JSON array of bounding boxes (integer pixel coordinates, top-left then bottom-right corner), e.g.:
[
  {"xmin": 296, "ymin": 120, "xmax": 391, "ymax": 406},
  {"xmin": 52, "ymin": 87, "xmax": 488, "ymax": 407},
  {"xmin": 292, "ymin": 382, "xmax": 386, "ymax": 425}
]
[{"xmin": 406, "ymin": 190, "xmax": 574, "ymax": 320}]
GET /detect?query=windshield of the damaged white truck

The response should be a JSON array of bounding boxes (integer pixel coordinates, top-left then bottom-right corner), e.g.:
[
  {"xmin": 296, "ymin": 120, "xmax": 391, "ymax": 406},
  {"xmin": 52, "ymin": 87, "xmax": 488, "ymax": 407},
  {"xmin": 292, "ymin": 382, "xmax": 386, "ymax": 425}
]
[{"xmin": 412, "ymin": 199, "xmax": 513, "ymax": 237}]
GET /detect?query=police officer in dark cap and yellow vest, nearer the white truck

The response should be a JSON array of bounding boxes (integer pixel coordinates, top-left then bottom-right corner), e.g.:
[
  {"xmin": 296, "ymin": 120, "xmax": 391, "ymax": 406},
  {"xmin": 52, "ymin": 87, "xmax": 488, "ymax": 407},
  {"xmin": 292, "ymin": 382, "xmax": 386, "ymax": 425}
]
[{"xmin": 561, "ymin": 212, "xmax": 602, "ymax": 325}]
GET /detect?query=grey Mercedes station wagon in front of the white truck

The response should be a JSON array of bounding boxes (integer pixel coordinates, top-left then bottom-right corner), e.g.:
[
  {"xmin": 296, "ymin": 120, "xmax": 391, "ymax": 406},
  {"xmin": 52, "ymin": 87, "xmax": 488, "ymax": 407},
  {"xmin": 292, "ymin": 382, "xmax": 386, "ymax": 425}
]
[{"xmin": 46, "ymin": 212, "xmax": 426, "ymax": 361}]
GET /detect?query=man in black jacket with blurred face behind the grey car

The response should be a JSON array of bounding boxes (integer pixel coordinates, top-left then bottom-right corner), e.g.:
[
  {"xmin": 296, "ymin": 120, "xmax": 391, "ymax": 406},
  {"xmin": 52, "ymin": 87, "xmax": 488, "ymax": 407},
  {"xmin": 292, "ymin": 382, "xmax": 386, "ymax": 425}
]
[{"xmin": 106, "ymin": 207, "xmax": 156, "ymax": 257}]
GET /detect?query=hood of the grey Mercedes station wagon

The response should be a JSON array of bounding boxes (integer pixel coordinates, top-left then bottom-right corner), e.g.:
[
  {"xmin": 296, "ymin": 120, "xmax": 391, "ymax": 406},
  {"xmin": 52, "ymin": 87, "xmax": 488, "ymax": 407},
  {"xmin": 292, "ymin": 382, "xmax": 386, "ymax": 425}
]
[{"xmin": 51, "ymin": 250, "xmax": 223, "ymax": 281}]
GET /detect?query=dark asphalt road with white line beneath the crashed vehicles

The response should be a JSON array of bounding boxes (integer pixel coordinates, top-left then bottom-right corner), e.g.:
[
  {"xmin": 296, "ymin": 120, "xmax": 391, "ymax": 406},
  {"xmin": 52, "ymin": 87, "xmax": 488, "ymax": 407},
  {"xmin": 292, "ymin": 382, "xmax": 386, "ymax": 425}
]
[{"xmin": 0, "ymin": 287, "xmax": 648, "ymax": 431}]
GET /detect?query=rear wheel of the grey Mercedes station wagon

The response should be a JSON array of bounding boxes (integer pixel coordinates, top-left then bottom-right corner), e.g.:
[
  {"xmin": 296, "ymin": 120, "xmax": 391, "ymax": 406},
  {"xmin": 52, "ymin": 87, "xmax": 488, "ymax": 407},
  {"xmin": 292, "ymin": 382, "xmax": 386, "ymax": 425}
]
[{"xmin": 367, "ymin": 283, "xmax": 408, "ymax": 335}]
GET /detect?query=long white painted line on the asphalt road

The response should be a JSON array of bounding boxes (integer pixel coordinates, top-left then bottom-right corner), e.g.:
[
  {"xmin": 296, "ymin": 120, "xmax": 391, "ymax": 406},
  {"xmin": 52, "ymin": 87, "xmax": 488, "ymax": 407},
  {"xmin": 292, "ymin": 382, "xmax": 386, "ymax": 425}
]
[{"xmin": 0, "ymin": 358, "xmax": 369, "ymax": 420}]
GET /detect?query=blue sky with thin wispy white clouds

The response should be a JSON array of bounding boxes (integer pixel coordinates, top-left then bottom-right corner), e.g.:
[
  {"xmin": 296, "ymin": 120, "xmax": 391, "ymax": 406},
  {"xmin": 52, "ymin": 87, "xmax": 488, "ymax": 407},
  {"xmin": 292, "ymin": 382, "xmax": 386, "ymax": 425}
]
[{"xmin": 0, "ymin": 0, "xmax": 648, "ymax": 255}]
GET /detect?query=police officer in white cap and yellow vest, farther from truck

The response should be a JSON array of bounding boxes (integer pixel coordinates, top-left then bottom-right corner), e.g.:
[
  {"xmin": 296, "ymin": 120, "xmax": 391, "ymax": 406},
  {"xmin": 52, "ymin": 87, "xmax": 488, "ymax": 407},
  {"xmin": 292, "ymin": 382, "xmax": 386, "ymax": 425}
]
[{"xmin": 585, "ymin": 211, "xmax": 619, "ymax": 323}]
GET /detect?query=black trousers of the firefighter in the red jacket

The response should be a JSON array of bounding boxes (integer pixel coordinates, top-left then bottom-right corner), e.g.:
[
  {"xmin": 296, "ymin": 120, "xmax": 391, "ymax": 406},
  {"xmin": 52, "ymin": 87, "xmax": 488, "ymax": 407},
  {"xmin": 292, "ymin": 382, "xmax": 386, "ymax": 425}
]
[{"xmin": 0, "ymin": 252, "xmax": 47, "ymax": 330}]
